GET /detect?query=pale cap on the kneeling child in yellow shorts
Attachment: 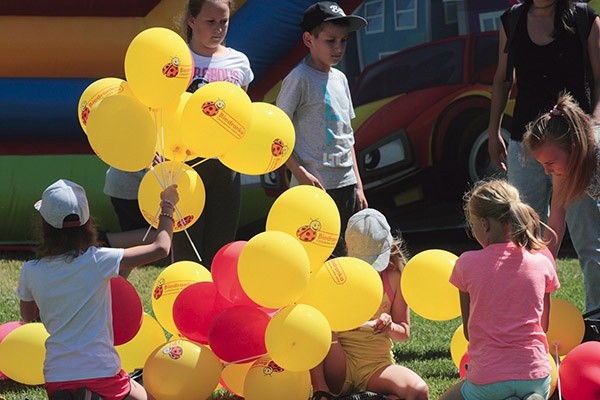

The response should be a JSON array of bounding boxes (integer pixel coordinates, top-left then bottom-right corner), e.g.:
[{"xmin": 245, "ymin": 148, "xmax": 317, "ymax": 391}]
[{"xmin": 345, "ymin": 208, "xmax": 394, "ymax": 272}]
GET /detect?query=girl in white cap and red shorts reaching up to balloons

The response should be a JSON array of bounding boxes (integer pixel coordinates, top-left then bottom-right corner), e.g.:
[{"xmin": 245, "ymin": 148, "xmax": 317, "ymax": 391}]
[{"xmin": 17, "ymin": 179, "xmax": 179, "ymax": 400}]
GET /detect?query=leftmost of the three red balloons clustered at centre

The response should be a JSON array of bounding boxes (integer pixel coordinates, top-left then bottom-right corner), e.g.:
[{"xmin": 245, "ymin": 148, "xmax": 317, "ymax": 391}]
[{"xmin": 173, "ymin": 282, "xmax": 233, "ymax": 344}]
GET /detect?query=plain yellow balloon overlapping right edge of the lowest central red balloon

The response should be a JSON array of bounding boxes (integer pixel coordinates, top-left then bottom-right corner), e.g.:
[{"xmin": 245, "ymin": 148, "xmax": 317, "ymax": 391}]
[{"xmin": 265, "ymin": 304, "xmax": 331, "ymax": 371}]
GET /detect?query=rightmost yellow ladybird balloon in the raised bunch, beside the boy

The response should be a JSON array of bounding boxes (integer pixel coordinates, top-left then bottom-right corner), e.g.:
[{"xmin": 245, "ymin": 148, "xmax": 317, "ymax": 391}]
[{"xmin": 219, "ymin": 102, "xmax": 296, "ymax": 175}]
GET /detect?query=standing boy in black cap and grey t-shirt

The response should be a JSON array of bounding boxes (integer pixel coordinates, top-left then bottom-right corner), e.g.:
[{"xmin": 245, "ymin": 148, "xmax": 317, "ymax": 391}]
[{"xmin": 277, "ymin": 1, "xmax": 368, "ymax": 256}]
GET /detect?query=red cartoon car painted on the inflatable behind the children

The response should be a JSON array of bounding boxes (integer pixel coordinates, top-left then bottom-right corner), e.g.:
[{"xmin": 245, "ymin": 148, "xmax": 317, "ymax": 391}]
[{"xmin": 264, "ymin": 32, "xmax": 514, "ymax": 231}]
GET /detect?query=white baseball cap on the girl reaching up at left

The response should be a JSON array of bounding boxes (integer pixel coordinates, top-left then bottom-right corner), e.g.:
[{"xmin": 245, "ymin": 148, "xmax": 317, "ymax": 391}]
[{"xmin": 34, "ymin": 179, "xmax": 90, "ymax": 229}]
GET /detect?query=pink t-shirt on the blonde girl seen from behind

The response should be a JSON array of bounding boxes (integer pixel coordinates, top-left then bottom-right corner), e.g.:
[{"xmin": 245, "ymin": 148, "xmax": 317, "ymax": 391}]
[{"xmin": 450, "ymin": 242, "xmax": 560, "ymax": 385}]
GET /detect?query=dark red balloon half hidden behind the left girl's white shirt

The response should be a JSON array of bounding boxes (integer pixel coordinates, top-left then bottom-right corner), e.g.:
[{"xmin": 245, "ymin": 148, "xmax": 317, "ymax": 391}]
[{"xmin": 110, "ymin": 276, "xmax": 144, "ymax": 346}]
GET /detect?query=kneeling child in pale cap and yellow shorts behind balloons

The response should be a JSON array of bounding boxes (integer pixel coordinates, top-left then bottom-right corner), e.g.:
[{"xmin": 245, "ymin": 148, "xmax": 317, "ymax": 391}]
[{"xmin": 311, "ymin": 208, "xmax": 429, "ymax": 400}]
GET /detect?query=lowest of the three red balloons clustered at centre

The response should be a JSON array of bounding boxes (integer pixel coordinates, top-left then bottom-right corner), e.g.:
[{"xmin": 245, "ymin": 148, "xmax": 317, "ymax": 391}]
[{"xmin": 208, "ymin": 306, "xmax": 270, "ymax": 363}]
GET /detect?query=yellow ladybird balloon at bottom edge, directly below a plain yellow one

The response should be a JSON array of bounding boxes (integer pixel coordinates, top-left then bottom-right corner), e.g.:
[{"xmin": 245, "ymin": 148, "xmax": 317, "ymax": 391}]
[{"xmin": 244, "ymin": 357, "xmax": 311, "ymax": 400}]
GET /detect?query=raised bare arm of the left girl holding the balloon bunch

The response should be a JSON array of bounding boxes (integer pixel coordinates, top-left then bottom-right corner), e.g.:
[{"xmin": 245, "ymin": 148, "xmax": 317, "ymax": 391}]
[{"xmin": 120, "ymin": 185, "xmax": 179, "ymax": 268}]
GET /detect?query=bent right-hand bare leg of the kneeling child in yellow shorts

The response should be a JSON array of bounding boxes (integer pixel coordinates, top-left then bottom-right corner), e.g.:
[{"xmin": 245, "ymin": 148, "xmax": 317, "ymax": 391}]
[{"xmin": 367, "ymin": 364, "xmax": 429, "ymax": 400}]
